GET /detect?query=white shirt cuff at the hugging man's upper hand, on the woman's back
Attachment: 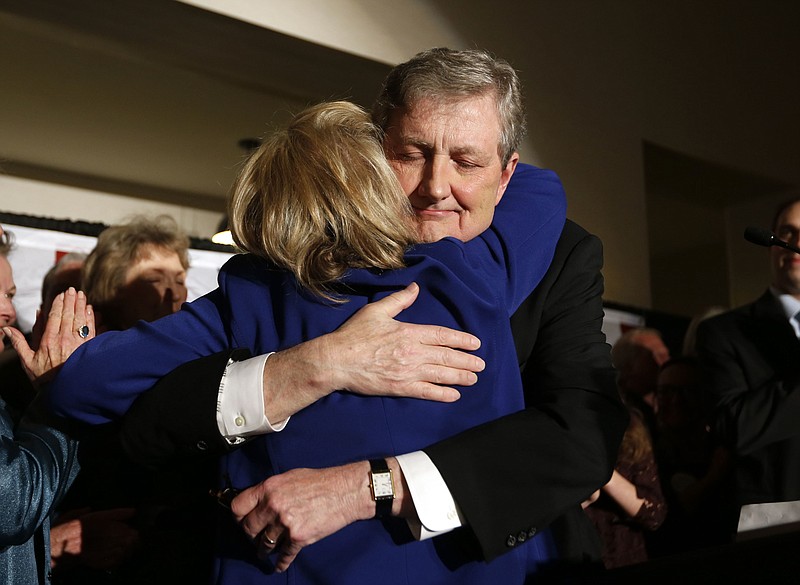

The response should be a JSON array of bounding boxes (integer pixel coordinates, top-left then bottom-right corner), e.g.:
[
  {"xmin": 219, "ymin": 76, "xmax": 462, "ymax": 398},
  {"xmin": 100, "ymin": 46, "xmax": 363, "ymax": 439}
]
[{"xmin": 217, "ymin": 353, "xmax": 289, "ymax": 444}]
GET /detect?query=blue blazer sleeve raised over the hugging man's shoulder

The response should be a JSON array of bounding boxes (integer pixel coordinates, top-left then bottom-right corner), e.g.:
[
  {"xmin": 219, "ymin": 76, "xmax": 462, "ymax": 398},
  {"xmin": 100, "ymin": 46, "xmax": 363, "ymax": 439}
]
[{"xmin": 482, "ymin": 163, "xmax": 567, "ymax": 315}]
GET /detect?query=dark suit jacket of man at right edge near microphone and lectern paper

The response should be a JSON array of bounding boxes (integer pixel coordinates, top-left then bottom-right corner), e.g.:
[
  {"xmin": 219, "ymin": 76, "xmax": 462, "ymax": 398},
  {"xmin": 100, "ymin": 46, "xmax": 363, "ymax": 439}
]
[{"xmin": 697, "ymin": 291, "xmax": 800, "ymax": 505}]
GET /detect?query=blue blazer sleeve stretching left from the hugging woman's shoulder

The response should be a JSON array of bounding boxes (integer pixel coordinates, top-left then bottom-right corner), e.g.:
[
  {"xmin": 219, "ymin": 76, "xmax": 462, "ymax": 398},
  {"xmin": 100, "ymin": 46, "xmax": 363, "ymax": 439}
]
[{"xmin": 48, "ymin": 289, "xmax": 229, "ymax": 424}]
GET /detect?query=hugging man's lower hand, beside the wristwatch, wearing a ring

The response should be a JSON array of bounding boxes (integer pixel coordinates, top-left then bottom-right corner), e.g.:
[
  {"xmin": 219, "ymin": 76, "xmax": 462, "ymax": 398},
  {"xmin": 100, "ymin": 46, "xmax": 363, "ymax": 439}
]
[{"xmin": 231, "ymin": 461, "xmax": 375, "ymax": 572}]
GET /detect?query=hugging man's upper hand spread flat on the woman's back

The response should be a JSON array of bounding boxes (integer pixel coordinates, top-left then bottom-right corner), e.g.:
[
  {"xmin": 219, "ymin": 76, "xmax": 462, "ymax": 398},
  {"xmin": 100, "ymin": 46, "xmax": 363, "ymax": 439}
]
[{"xmin": 264, "ymin": 283, "xmax": 485, "ymax": 421}]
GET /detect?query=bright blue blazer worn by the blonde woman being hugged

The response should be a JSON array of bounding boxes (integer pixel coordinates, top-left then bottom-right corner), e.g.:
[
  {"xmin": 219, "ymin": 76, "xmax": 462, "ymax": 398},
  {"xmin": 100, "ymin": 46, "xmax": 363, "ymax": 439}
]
[{"xmin": 51, "ymin": 165, "xmax": 565, "ymax": 583}]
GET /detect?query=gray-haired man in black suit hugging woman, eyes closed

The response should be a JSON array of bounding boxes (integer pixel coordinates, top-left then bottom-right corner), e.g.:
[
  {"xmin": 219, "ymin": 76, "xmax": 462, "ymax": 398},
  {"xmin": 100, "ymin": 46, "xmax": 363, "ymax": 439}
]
[{"xmin": 53, "ymin": 49, "xmax": 627, "ymax": 582}]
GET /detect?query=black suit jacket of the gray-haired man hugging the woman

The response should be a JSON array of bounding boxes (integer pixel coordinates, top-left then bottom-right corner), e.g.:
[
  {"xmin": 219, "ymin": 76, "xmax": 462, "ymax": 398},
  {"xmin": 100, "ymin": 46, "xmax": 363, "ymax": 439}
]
[{"xmin": 123, "ymin": 221, "xmax": 628, "ymax": 560}]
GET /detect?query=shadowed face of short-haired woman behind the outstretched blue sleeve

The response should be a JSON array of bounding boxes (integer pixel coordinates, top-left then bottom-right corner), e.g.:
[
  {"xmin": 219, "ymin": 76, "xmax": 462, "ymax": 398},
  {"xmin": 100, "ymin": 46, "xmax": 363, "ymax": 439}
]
[{"xmin": 115, "ymin": 246, "xmax": 187, "ymax": 329}]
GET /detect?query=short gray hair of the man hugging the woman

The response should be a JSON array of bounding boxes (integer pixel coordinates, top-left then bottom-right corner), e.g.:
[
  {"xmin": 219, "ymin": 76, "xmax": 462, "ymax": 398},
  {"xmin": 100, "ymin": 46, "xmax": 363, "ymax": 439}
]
[{"xmin": 372, "ymin": 48, "xmax": 526, "ymax": 166}]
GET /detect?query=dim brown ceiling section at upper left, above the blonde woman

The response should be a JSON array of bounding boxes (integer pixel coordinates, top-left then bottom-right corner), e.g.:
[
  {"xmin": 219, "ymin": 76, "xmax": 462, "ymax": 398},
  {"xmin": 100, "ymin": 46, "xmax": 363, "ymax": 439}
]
[{"xmin": 0, "ymin": 0, "xmax": 388, "ymax": 210}]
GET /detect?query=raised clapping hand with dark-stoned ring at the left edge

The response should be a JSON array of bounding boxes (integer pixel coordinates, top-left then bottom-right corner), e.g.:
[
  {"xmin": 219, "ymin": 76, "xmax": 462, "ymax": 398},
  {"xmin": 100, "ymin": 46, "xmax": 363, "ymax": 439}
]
[{"xmin": 3, "ymin": 287, "xmax": 95, "ymax": 385}]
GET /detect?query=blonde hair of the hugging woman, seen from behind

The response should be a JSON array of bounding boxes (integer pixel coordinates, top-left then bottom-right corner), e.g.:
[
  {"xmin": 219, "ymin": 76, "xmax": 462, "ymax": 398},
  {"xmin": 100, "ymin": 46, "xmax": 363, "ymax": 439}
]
[{"xmin": 228, "ymin": 102, "xmax": 417, "ymax": 302}]
